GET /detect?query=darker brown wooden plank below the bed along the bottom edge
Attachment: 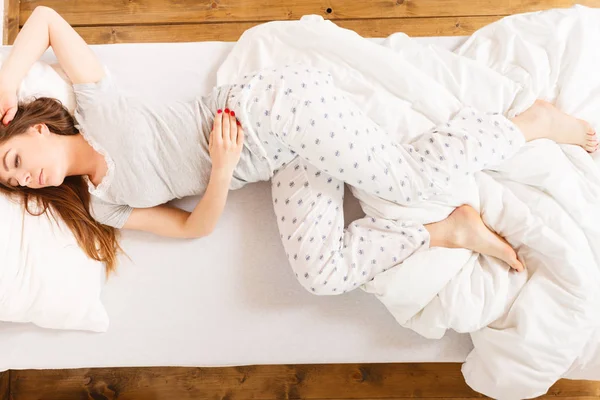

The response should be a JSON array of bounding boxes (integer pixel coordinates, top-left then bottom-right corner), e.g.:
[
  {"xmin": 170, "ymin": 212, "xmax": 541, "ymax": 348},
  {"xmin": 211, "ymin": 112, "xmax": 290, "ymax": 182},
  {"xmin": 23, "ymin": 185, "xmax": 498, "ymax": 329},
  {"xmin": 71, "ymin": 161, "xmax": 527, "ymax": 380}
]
[{"xmin": 11, "ymin": 364, "xmax": 600, "ymax": 400}]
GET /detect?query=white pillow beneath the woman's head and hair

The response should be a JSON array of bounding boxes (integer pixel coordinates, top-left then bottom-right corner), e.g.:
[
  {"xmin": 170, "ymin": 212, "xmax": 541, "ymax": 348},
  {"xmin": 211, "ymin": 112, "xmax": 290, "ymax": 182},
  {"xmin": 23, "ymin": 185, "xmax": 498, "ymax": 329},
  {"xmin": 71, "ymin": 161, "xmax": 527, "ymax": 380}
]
[{"xmin": 0, "ymin": 53, "xmax": 108, "ymax": 332}]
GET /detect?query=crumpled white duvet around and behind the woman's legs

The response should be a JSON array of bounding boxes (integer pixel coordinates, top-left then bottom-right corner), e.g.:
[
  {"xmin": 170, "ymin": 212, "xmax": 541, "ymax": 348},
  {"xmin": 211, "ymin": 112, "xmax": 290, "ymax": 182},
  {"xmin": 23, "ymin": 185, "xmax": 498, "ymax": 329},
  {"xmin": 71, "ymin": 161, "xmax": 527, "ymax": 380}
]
[{"xmin": 218, "ymin": 6, "xmax": 600, "ymax": 399}]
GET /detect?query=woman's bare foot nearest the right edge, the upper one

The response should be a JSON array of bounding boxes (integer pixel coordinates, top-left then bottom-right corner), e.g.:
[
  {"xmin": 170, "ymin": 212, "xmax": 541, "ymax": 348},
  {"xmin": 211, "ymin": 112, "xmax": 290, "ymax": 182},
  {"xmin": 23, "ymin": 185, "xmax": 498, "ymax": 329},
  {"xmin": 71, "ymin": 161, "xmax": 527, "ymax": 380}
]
[{"xmin": 513, "ymin": 100, "xmax": 598, "ymax": 153}]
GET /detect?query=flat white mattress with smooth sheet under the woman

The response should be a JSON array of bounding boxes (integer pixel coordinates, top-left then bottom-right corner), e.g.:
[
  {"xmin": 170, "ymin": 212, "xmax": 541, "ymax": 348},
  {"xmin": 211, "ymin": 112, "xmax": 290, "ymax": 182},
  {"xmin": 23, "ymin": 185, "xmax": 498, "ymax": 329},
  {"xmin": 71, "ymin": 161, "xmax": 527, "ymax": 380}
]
[{"xmin": 0, "ymin": 38, "xmax": 472, "ymax": 370}]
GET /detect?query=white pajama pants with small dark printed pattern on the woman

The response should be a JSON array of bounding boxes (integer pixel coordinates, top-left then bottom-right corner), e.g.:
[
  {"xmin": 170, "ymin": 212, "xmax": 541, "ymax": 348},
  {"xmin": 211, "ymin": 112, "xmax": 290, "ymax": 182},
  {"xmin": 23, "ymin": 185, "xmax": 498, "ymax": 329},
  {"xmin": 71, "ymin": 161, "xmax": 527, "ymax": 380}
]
[{"xmin": 232, "ymin": 65, "xmax": 525, "ymax": 295}]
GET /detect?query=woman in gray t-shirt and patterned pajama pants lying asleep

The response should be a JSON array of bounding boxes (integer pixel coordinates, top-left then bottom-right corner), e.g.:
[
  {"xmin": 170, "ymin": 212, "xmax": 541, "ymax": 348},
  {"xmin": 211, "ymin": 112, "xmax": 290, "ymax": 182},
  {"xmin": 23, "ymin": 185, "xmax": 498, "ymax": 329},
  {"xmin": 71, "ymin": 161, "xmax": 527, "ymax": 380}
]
[{"xmin": 0, "ymin": 7, "xmax": 598, "ymax": 295}]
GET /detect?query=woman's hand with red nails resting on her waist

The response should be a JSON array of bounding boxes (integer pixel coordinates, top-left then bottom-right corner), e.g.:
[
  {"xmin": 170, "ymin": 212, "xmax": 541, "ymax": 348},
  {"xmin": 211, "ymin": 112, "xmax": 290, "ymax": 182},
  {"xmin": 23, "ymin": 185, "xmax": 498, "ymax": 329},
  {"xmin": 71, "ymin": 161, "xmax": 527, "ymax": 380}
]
[{"xmin": 208, "ymin": 108, "xmax": 244, "ymax": 175}]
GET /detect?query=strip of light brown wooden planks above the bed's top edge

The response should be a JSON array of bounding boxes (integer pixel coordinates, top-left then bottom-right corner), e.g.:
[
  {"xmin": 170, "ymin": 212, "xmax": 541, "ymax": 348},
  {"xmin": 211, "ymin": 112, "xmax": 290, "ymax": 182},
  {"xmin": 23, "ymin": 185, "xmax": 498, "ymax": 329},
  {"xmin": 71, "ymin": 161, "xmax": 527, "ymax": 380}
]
[{"xmin": 4, "ymin": 0, "xmax": 600, "ymax": 44}]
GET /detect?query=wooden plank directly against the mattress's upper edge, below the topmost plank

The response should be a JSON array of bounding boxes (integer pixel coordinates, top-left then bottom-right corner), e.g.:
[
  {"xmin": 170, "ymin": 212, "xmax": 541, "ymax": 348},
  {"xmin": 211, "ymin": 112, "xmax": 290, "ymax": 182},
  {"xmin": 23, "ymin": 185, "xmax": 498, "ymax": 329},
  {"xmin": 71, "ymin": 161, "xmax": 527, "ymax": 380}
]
[{"xmin": 68, "ymin": 17, "xmax": 500, "ymax": 44}]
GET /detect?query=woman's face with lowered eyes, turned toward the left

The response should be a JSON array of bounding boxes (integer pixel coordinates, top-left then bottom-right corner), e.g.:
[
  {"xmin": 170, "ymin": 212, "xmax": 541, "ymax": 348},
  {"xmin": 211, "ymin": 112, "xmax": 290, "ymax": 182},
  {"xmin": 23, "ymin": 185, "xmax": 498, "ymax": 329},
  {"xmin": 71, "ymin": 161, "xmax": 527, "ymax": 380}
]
[{"xmin": 0, "ymin": 124, "xmax": 67, "ymax": 189}]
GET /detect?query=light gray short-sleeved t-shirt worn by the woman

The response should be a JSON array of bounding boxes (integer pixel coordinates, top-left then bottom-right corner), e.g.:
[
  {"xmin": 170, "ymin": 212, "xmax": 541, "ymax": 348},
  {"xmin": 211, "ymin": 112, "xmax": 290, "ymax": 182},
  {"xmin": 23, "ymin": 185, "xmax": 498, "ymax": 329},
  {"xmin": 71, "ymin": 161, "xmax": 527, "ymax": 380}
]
[{"xmin": 73, "ymin": 72, "xmax": 272, "ymax": 228}]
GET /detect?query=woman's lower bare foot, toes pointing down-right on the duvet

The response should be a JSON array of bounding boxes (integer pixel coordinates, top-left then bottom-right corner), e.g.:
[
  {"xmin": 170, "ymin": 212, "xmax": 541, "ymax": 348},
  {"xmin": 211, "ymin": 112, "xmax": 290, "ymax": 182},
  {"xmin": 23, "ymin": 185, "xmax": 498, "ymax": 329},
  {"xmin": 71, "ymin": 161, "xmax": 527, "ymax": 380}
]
[{"xmin": 425, "ymin": 205, "xmax": 525, "ymax": 272}]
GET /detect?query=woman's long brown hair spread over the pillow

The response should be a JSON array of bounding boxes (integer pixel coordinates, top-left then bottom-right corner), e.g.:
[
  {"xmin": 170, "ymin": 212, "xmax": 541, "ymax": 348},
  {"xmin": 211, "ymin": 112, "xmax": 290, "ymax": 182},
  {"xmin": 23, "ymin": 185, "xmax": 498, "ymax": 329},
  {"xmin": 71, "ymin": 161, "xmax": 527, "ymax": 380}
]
[{"xmin": 0, "ymin": 97, "xmax": 120, "ymax": 273}]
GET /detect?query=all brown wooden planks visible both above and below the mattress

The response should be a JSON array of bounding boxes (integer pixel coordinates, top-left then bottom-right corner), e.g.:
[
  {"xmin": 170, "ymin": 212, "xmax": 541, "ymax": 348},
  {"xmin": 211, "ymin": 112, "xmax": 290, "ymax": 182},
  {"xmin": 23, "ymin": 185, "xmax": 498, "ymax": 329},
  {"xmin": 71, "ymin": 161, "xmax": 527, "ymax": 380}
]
[{"xmin": 0, "ymin": 0, "xmax": 600, "ymax": 400}]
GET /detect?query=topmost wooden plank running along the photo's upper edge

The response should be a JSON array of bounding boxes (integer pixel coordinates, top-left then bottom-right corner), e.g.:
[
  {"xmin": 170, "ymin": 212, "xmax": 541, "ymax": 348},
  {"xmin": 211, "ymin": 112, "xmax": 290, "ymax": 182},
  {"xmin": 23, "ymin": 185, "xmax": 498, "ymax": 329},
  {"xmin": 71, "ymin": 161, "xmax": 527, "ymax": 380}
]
[{"xmin": 21, "ymin": 0, "xmax": 600, "ymax": 26}]
